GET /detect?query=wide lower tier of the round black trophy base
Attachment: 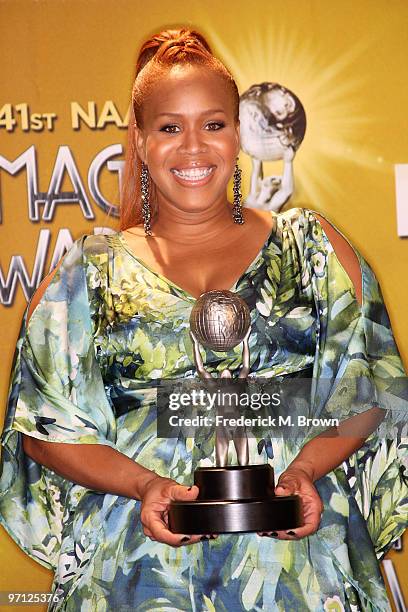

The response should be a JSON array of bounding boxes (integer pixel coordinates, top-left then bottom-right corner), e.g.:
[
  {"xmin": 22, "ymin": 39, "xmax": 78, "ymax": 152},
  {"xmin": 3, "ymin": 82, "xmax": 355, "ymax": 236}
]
[{"xmin": 169, "ymin": 495, "xmax": 303, "ymax": 535}]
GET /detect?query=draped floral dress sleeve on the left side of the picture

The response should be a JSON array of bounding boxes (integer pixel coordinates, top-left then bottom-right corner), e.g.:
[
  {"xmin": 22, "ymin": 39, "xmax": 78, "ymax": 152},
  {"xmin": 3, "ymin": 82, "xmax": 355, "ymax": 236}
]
[{"xmin": 0, "ymin": 237, "xmax": 116, "ymax": 568}]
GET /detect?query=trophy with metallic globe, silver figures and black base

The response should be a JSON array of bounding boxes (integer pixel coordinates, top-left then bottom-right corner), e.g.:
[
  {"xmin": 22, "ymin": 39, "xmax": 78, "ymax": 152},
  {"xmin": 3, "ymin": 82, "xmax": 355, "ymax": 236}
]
[{"xmin": 168, "ymin": 290, "xmax": 303, "ymax": 534}]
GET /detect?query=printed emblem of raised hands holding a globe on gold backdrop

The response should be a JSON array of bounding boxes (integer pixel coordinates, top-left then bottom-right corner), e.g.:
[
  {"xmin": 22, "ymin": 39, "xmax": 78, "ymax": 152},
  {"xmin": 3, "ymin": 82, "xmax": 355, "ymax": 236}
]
[{"xmin": 239, "ymin": 82, "xmax": 306, "ymax": 211}]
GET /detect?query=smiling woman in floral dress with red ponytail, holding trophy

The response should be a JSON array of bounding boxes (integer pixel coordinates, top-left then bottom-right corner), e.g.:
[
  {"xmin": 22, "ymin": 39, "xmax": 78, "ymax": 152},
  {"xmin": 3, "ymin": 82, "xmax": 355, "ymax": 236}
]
[{"xmin": 0, "ymin": 30, "xmax": 407, "ymax": 611}]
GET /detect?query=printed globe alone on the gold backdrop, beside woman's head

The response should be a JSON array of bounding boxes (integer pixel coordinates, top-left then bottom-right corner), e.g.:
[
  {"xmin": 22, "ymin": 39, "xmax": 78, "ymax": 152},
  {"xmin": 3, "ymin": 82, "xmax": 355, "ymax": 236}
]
[{"xmin": 239, "ymin": 82, "xmax": 306, "ymax": 161}]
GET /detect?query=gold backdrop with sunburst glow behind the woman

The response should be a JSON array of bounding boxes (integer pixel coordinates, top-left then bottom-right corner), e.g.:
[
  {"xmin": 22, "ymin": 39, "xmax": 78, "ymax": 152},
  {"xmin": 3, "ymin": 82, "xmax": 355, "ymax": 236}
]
[{"xmin": 0, "ymin": 0, "xmax": 408, "ymax": 601}]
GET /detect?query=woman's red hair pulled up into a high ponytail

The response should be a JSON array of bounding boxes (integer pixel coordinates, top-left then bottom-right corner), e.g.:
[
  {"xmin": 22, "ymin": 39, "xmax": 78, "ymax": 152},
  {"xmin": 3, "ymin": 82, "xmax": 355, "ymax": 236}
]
[{"xmin": 120, "ymin": 28, "xmax": 239, "ymax": 230}]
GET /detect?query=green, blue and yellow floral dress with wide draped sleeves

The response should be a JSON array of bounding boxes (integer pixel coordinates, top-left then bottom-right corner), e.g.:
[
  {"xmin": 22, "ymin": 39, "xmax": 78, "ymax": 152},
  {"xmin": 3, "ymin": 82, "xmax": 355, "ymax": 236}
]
[{"xmin": 0, "ymin": 209, "xmax": 408, "ymax": 612}]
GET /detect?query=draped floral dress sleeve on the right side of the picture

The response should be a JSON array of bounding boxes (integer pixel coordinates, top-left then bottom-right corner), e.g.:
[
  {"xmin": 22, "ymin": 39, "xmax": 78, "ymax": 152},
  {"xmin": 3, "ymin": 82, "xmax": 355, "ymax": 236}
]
[{"xmin": 304, "ymin": 211, "xmax": 408, "ymax": 558}]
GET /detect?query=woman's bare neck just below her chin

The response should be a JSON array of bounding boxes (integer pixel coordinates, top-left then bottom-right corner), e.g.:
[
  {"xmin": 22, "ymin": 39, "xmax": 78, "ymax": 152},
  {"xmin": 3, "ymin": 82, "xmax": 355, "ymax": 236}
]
[{"xmin": 152, "ymin": 199, "xmax": 238, "ymax": 244}]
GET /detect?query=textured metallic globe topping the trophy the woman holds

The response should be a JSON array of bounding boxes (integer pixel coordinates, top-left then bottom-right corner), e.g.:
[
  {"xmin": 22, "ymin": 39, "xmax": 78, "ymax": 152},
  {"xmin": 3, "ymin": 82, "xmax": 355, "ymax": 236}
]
[{"xmin": 190, "ymin": 290, "xmax": 251, "ymax": 352}]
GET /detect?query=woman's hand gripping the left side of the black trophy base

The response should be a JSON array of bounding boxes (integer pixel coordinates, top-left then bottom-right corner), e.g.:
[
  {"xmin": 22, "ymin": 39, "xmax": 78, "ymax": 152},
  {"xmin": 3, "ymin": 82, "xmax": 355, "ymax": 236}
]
[{"xmin": 140, "ymin": 476, "xmax": 217, "ymax": 546}]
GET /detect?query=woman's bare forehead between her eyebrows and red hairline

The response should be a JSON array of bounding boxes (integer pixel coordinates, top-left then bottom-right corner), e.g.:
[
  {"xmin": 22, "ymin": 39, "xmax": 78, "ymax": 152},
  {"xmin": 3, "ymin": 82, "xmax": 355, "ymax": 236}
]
[{"xmin": 143, "ymin": 65, "xmax": 234, "ymax": 119}]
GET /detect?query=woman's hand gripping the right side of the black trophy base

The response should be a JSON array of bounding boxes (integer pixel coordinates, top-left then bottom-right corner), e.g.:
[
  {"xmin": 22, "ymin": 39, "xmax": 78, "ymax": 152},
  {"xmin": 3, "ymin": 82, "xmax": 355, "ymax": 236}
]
[{"xmin": 265, "ymin": 466, "xmax": 323, "ymax": 540}]
